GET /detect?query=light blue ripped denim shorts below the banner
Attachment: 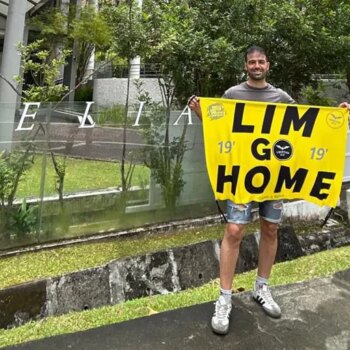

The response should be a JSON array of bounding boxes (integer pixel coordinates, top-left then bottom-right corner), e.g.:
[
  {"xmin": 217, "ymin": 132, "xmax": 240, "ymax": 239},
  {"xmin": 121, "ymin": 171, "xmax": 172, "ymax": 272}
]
[{"xmin": 227, "ymin": 200, "xmax": 283, "ymax": 224}]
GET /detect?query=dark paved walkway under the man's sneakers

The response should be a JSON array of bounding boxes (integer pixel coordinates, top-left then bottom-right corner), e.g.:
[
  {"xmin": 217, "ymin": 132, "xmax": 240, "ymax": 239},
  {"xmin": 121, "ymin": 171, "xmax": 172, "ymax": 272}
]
[{"xmin": 7, "ymin": 270, "xmax": 350, "ymax": 350}]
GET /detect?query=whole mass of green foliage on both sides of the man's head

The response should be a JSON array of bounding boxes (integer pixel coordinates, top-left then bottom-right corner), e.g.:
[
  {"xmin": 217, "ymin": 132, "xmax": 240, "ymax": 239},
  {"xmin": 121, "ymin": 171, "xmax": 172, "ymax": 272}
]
[{"xmin": 137, "ymin": 0, "xmax": 350, "ymax": 104}]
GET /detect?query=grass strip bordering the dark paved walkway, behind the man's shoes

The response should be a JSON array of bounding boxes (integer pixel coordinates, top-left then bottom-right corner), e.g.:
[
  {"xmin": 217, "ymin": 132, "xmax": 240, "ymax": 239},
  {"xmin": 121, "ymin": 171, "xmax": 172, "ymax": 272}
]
[{"xmin": 0, "ymin": 246, "xmax": 350, "ymax": 347}]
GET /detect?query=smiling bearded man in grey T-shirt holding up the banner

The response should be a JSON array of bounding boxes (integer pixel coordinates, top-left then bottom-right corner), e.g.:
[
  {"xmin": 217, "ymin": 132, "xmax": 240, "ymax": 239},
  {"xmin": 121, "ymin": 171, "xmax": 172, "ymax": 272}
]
[{"xmin": 188, "ymin": 46, "xmax": 350, "ymax": 334}]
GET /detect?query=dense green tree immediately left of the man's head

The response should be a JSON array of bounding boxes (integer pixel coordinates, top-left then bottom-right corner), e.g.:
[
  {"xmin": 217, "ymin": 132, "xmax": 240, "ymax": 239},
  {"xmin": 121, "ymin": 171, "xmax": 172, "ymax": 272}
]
[{"xmin": 140, "ymin": 0, "xmax": 258, "ymax": 105}]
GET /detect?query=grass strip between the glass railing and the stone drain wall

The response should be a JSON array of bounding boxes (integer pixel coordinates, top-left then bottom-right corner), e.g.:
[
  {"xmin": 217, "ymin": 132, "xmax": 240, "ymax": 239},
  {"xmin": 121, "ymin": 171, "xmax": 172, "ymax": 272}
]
[{"xmin": 0, "ymin": 225, "xmax": 223, "ymax": 288}]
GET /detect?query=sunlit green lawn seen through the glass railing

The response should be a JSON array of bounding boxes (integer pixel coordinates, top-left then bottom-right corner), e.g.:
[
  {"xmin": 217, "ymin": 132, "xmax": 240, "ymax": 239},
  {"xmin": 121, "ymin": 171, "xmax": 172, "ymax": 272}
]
[{"xmin": 17, "ymin": 155, "xmax": 150, "ymax": 198}]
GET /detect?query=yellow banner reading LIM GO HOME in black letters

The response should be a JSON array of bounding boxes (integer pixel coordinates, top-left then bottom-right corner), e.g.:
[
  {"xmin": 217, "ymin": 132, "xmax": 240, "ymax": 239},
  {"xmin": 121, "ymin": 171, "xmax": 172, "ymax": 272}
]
[{"xmin": 200, "ymin": 97, "xmax": 348, "ymax": 207}]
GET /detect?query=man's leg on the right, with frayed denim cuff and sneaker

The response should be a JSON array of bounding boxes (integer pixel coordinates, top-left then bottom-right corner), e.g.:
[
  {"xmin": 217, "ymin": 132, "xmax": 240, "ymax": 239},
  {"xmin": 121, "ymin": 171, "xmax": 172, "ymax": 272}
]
[{"xmin": 253, "ymin": 201, "xmax": 283, "ymax": 317}]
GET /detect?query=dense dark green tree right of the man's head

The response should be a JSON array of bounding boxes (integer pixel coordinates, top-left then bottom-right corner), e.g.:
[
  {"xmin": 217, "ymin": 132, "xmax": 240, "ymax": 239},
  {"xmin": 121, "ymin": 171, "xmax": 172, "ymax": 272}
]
[{"xmin": 253, "ymin": 0, "xmax": 350, "ymax": 98}]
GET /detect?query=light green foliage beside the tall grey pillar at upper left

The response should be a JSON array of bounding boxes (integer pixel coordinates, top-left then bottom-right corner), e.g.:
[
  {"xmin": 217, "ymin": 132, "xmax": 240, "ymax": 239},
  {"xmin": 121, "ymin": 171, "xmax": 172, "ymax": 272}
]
[{"xmin": 24, "ymin": 5, "xmax": 111, "ymax": 97}]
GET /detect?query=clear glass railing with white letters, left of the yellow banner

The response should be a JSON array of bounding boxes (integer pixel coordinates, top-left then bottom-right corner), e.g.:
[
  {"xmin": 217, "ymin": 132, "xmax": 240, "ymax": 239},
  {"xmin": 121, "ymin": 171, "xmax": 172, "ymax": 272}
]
[{"xmin": 1, "ymin": 102, "xmax": 217, "ymax": 250}]
